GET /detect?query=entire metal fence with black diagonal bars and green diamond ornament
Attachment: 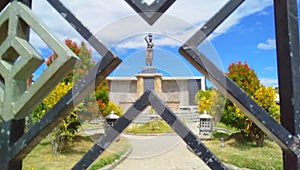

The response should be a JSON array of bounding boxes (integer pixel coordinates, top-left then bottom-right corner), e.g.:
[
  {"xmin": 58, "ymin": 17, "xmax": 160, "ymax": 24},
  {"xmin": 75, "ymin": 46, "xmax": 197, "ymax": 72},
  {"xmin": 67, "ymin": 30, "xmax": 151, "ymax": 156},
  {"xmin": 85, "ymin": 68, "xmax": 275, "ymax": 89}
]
[{"xmin": 0, "ymin": 0, "xmax": 300, "ymax": 169}]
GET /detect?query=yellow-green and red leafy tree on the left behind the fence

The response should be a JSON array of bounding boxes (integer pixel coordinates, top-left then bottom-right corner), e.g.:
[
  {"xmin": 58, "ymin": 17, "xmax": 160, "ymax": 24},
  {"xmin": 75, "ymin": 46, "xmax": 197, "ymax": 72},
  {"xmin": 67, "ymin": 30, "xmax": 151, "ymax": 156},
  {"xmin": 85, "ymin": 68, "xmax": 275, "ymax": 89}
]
[{"xmin": 32, "ymin": 39, "xmax": 108, "ymax": 152}]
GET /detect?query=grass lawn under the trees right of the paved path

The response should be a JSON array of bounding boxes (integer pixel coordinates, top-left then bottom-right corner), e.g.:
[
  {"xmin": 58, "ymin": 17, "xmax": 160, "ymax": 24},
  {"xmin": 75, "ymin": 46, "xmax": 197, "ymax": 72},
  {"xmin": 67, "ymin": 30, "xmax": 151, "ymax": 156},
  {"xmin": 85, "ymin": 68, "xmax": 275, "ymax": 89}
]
[{"xmin": 204, "ymin": 133, "xmax": 283, "ymax": 170}]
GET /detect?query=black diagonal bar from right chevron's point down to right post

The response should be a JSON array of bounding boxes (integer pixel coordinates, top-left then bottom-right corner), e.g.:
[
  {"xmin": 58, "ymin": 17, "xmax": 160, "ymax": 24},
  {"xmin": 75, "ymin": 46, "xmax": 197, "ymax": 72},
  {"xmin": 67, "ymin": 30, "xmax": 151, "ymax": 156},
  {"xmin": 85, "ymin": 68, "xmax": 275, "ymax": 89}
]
[{"xmin": 180, "ymin": 46, "xmax": 299, "ymax": 155}]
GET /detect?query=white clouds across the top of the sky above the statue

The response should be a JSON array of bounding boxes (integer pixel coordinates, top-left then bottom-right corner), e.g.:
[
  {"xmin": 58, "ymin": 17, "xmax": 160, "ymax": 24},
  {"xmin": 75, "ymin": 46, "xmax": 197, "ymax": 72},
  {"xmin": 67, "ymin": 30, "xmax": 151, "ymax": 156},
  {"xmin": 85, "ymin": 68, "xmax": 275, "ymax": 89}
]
[{"xmin": 28, "ymin": 0, "xmax": 272, "ymax": 52}]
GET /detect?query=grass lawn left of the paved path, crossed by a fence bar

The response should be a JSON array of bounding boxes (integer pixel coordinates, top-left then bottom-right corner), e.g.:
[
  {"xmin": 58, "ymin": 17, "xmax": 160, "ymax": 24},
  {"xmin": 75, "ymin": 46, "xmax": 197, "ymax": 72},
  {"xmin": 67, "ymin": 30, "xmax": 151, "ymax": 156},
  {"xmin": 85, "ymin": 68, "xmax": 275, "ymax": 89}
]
[{"xmin": 23, "ymin": 135, "xmax": 130, "ymax": 170}]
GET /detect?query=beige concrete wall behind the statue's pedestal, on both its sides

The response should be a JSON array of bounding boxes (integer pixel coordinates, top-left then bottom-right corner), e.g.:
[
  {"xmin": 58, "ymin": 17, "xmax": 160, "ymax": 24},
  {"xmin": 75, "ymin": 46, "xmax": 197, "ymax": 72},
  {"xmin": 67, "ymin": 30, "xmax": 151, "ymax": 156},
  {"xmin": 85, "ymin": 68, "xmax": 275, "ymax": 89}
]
[{"xmin": 108, "ymin": 77, "xmax": 205, "ymax": 112}]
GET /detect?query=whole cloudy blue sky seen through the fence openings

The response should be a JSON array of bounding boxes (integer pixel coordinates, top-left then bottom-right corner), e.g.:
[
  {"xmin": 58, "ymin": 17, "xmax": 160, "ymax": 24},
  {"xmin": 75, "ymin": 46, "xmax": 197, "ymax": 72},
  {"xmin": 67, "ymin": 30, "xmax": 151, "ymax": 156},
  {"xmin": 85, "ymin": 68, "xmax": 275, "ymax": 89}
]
[{"xmin": 31, "ymin": 0, "xmax": 288, "ymax": 87}]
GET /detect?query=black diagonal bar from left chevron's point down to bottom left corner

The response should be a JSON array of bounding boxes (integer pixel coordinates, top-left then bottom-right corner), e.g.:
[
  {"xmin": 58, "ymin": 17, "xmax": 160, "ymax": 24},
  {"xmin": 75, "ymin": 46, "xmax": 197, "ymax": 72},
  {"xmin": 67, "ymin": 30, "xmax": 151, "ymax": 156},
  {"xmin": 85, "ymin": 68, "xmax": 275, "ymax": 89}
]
[{"xmin": 9, "ymin": 57, "xmax": 121, "ymax": 159}]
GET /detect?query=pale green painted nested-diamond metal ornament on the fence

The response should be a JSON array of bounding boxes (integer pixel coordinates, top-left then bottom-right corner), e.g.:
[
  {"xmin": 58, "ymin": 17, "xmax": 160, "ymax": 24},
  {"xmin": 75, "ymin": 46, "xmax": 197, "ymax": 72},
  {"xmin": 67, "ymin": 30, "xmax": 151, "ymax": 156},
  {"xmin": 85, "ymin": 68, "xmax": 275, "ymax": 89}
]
[{"xmin": 0, "ymin": 1, "xmax": 79, "ymax": 121}]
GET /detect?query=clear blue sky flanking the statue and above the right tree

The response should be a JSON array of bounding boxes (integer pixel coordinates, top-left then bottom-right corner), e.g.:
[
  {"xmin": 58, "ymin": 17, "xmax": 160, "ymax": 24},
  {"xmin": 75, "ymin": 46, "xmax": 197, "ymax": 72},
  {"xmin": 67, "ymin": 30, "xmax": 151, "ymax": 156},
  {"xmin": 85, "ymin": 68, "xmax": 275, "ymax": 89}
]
[{"xmin": 108, "ymin": 3, "xmax": 278, "ymax": 87}]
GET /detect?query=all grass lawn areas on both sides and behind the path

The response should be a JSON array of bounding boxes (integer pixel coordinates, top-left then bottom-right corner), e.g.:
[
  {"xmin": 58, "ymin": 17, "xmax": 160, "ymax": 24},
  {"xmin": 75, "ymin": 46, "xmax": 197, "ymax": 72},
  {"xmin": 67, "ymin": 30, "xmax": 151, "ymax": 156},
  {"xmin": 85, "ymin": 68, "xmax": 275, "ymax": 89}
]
[{"xmin": 23, "ymin": 121, "xmax": 283, "ymax": 170}]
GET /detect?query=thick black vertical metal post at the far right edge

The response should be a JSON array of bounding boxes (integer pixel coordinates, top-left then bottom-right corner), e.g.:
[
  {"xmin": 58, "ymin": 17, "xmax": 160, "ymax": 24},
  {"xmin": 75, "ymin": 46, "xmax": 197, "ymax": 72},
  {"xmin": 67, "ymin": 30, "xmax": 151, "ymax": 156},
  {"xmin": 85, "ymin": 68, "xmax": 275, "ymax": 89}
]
[{"xmin": 274, "ymin": 0, "xmax": 300, "ymax": 169}]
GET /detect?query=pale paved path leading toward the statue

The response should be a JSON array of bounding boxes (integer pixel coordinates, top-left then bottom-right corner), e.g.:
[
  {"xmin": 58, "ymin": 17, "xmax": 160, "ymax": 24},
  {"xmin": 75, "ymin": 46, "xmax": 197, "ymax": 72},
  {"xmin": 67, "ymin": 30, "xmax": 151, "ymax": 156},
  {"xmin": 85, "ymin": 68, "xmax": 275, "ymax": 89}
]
[{"xmin": 115, "ymin": 125, "xmax": 210, "ymax": 170}]
